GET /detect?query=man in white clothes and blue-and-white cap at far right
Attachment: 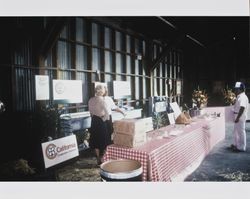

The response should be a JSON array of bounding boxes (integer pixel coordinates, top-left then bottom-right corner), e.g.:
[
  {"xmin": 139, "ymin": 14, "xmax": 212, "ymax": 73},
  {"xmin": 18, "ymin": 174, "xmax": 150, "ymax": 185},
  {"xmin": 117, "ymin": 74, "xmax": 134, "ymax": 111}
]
[{"xmin": 231, "ymin": 82, "xmax": 249, "ymax": 152}]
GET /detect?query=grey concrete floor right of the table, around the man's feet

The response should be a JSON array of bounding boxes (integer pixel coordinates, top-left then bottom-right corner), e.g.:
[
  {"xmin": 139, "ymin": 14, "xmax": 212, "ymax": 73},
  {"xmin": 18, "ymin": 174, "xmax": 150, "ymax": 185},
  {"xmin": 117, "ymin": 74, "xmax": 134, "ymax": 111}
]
[{"xmin": 185, "ymin": 122, "xmax": 250, "ymax": 181}]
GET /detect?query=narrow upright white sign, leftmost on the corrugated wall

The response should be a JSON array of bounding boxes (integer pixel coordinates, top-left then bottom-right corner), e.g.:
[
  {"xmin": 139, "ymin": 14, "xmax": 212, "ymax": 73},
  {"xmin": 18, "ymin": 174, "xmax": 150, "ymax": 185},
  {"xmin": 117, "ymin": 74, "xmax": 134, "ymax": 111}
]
[{"xmin": 35, "ymin": 75, "xmax": 49, "ymax": 100}]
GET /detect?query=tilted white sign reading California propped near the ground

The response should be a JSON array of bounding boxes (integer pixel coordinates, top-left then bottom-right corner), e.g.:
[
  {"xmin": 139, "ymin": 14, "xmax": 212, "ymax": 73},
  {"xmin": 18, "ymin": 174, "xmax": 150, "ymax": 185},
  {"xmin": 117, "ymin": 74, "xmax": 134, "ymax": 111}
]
[{"xmin": 42, "ymin": 135, "xmax": 79, "ymax": 168}]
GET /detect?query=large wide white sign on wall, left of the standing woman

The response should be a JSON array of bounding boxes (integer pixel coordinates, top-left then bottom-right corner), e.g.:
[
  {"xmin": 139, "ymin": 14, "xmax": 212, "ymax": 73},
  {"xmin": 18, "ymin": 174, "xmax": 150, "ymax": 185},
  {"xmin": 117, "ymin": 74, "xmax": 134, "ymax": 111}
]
[{"xmin": 53, "ymin": 79, "xmax": 83, "ymax": 103}]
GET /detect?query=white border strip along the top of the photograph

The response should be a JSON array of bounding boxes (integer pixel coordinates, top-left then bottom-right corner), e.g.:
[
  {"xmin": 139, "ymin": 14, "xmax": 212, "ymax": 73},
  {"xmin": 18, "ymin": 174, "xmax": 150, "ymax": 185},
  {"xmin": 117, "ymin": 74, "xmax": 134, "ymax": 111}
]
[{"xmin": 0, "ymin": 0, "xmax": 249, "ymax": 16}]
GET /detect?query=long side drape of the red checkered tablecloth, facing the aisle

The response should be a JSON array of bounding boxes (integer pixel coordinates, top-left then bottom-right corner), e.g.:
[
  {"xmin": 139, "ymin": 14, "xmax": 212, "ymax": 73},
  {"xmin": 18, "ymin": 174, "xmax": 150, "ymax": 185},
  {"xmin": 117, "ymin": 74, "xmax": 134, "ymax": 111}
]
[{"xmin": 149, "ymin": 126, "xmax": 208, "ymax": 181}]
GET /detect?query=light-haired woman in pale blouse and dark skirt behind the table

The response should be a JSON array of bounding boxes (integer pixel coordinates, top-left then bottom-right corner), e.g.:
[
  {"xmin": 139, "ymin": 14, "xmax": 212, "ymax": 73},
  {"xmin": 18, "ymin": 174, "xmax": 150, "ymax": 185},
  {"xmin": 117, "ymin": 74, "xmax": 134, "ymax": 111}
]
[{"xmin": 88, "ymin": 85, "xmax": 111, "ymax": 165}]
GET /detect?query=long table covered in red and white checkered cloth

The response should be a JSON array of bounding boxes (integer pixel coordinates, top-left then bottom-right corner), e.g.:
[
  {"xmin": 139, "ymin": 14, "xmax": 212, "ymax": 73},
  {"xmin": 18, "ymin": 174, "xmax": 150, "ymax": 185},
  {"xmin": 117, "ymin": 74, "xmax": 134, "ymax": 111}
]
[{"xmin": 104, "ymin": 107, "xmax": 225, "ymax": 181}]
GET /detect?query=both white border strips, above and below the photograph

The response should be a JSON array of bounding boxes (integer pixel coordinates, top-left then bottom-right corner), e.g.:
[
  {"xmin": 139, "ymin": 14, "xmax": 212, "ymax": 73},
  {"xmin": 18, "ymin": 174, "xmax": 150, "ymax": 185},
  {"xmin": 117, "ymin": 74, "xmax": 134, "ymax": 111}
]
[{"xmin": 0, "ymin": 0, "xmax": 250, "ymax": 199}]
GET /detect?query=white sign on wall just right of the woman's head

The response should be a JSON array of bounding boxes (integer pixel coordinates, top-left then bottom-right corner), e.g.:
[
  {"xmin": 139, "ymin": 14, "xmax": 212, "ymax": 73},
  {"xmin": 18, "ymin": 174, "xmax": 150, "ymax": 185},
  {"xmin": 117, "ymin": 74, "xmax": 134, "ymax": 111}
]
[{"xmin": 113, "ymin": 81, "xmax": 131, "ymax": 99}]
